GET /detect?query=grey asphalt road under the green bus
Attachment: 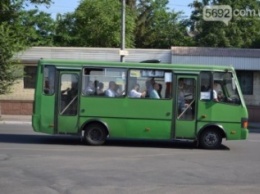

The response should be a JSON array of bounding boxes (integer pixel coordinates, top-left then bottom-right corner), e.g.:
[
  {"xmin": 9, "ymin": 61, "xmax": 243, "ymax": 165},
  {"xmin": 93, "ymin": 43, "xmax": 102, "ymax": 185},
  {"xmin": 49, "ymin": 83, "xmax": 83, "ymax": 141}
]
[{"xmin": 0, "ymin": 125, "xmax": 260, "ymax": 194}]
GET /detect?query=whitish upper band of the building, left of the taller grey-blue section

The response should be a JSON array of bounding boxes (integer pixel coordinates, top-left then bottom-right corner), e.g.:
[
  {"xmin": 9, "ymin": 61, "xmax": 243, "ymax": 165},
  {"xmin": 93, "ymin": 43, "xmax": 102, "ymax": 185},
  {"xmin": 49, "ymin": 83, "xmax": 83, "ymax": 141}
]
[{"xmin": 16, "ymin": 47, "xmax": 171, "ymax": 63}]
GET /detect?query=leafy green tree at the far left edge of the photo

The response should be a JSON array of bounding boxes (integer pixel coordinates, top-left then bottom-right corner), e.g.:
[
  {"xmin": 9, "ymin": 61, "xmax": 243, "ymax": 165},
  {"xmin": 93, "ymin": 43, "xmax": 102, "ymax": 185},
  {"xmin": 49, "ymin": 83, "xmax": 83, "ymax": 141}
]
[{"xmin": 0, "ymin": 0, "xmax": 51, "ymax": 94}]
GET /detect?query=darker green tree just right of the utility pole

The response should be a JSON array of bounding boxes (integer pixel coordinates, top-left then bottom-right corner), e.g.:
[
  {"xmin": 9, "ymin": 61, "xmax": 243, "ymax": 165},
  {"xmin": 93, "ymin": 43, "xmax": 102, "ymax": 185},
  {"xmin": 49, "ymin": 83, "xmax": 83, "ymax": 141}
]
[{"xmin": 135, "ymin": 0, "xmax": 192, "ymax": 48}]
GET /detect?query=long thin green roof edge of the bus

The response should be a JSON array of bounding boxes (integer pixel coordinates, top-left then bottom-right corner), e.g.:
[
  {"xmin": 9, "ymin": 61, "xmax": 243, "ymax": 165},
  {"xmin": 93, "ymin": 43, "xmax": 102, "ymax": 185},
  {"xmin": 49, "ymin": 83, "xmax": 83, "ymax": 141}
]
[{"xmin": 38, "ymin": 59, "xmax": 234, "ymax": 71}]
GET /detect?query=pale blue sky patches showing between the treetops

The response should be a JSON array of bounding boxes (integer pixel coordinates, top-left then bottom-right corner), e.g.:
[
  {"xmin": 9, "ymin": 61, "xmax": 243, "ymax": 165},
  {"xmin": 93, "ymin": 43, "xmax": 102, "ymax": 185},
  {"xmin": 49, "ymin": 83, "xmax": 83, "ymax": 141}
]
[{"xmin": 29, "ymin": 0, "xmax": 193, "ymax": 18}]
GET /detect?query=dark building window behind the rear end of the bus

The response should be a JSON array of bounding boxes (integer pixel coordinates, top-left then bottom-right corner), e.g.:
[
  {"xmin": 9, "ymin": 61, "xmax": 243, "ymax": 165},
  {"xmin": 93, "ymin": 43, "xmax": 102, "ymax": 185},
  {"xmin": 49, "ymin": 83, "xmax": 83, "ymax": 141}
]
[{"xmin": 23, "ymin": 66, "xmax": 37, "ymax": 89}]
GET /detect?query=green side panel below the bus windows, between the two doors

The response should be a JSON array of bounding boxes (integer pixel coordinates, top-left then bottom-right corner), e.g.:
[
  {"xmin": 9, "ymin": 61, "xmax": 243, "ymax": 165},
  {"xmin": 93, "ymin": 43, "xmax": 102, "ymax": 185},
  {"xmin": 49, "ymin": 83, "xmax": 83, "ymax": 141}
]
[{"xmin": 80, "ymin": 97, "xmax": 172, "ymax": 139}]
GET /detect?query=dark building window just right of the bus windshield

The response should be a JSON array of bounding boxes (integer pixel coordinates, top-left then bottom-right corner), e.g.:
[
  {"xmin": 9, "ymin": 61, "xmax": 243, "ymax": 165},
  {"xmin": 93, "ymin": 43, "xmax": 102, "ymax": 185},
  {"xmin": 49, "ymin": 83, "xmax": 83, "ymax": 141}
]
[{"xmin": 237, "ymin": 71, "xmax": 254, "ymax": 95}]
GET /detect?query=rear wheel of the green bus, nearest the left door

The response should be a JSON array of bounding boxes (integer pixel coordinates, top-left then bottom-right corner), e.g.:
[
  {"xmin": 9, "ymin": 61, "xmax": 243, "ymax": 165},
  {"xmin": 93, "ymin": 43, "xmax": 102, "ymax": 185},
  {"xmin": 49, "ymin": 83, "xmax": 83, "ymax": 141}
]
[{"xmin": 84, "ymin": 123, "xmax": 107, "ymax": 145}]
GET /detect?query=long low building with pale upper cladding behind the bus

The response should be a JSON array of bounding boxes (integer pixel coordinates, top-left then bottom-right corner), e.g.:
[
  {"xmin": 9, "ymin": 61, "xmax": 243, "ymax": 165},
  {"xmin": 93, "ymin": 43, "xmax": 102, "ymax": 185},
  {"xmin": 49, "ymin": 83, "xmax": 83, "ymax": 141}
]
[{"xmin": 0, "ymin": 47, "xmax": 260, "ymax": 121}]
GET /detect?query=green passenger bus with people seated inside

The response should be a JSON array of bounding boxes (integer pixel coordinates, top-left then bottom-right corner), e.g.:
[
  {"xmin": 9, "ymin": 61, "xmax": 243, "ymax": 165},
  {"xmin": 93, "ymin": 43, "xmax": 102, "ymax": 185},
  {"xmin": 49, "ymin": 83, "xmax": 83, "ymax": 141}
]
[{"xmin": 32, "ymin": 59, "xmax": 248, "ymax": 149}]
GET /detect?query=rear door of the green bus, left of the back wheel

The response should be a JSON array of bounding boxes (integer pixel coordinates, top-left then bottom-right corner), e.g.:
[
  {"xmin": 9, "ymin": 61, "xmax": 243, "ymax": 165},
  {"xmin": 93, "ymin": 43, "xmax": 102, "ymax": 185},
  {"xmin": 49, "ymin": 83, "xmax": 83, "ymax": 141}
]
[{"xmin": 55, "ymin": 70, "xmax": 80, "ymax": 133}]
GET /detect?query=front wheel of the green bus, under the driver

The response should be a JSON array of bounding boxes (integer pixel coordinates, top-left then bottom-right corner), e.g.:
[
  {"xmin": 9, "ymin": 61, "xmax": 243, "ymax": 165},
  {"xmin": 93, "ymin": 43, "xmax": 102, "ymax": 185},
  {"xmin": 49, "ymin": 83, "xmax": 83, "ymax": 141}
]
[{"xmin": 199, "ymin": 129, "xmax": 222, "ymax": 149}]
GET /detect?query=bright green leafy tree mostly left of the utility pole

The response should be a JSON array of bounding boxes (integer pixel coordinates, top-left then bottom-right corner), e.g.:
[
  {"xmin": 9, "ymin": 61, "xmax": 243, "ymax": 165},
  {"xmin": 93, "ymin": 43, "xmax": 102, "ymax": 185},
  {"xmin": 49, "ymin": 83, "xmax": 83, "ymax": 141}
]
[{"xmin": 55, "ymin": 0, "xmax": 135, "ymax": 47}]
